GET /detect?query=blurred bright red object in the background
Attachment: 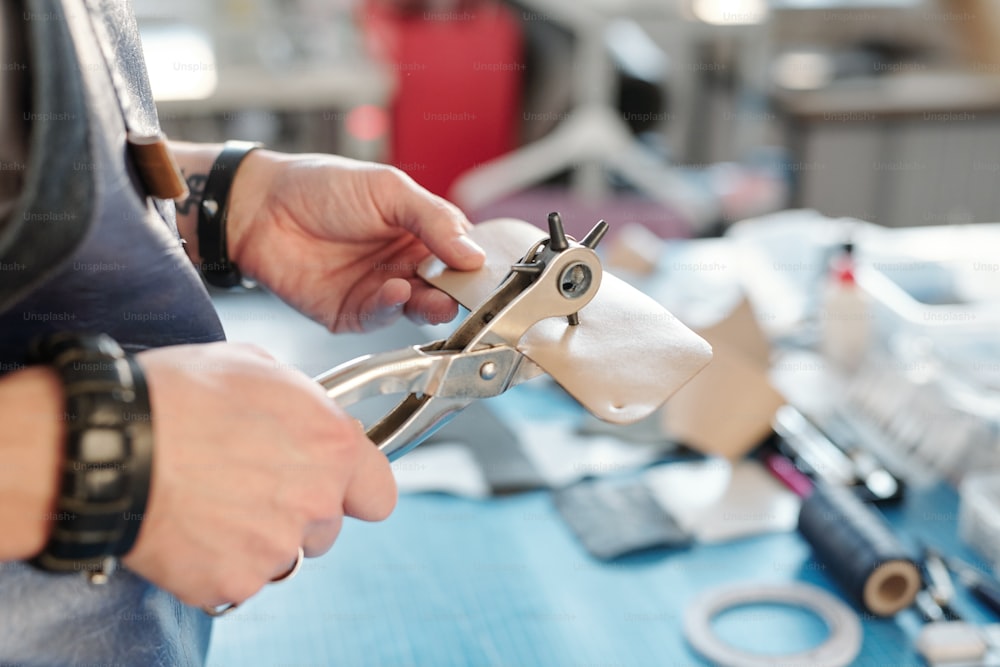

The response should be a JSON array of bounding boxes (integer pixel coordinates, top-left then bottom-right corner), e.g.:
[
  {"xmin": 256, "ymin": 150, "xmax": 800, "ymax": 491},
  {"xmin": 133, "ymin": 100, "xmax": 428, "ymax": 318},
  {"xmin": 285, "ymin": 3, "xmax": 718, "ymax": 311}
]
[{"xmin": 361, "ymin": 0, "xmax": 524, "ymax": 196}]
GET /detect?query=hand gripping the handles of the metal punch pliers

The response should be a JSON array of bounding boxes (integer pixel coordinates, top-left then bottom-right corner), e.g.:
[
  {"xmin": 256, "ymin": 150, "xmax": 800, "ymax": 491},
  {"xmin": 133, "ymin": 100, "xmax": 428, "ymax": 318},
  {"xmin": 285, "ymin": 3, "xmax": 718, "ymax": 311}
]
[{"xmin": 123, "ymin": 343, "xmax": 396, "ymax": 606}]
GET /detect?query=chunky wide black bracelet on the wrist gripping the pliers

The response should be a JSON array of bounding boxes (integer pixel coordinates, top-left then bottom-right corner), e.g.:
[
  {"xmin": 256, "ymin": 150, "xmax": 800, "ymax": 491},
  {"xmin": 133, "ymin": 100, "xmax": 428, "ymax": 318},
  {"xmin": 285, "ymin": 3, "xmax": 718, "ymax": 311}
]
[{"xmin": 29, "ymin": 332, "xmax": 153, "ymax": 584}]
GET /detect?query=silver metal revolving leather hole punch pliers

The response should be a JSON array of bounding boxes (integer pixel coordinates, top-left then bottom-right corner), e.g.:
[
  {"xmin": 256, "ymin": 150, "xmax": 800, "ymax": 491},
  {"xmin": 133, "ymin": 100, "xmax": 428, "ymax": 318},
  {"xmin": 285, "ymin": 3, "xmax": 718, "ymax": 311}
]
[{"xmin": 316, "ymin": 213, "xmax": 608, "ymax": 460}]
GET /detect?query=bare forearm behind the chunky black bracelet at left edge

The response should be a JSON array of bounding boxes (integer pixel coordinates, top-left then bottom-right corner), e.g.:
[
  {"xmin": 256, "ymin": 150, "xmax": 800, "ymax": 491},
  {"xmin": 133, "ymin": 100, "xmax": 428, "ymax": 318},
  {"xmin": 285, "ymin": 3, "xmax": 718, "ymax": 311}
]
[{"xmin": 0, "ymin": 368, "xmax": 65, "ymax": 561}]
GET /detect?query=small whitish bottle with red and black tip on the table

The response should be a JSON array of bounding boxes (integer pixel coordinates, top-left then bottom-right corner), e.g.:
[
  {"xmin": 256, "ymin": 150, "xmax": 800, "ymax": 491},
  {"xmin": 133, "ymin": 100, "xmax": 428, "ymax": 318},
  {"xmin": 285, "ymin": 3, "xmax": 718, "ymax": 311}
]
[{"xmin": 820, "ymin": 242, "xmax": 871, "ymax": 372}]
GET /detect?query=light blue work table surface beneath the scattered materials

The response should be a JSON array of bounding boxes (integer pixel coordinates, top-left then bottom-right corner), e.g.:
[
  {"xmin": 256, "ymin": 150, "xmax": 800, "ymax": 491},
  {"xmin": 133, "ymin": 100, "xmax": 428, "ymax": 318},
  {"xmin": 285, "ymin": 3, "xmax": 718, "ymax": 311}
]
[{"xmin": 209, "ymin": 218, "xmax": 996, "ymax": 667}]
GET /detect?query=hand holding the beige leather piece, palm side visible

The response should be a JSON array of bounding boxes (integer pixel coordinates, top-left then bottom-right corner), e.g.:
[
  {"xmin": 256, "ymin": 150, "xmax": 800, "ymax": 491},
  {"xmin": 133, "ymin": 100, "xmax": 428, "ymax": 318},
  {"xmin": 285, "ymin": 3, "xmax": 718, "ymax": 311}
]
[{"xmin": 227, "ymin": 149, "xmax": 484, "ymax": 331}]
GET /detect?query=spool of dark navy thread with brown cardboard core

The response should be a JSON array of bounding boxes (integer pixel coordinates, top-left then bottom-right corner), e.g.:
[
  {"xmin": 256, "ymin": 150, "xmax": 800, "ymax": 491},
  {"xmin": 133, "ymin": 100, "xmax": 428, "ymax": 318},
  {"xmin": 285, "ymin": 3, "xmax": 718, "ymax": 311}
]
[{"xmin": 799, "ymin": 484, "xmax": 921, "ymax": 616}]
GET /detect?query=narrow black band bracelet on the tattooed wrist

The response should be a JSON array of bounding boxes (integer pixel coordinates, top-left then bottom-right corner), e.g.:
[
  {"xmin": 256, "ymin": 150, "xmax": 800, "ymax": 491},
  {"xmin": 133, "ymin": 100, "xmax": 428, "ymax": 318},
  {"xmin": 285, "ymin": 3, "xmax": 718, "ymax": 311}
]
[{"xmin": 198, "ymin": 141, "xmax": 261, "ymax": 287}]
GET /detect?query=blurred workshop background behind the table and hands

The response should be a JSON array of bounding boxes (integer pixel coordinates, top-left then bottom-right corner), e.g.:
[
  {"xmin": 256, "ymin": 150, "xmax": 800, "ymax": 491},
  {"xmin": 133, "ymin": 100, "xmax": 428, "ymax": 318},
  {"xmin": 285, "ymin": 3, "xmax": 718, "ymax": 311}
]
[{"xmin": 135, "ymin": 0, "xmax": 1000, "ymax": 237}]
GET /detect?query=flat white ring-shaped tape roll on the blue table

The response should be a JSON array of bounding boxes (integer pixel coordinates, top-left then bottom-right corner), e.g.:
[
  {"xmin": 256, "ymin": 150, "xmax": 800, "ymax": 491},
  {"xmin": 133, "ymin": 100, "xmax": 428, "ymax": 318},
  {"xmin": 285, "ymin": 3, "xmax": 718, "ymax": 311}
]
[{"xmin": 684, "ymin": 583, "xmax": 861, "ymax": 667}]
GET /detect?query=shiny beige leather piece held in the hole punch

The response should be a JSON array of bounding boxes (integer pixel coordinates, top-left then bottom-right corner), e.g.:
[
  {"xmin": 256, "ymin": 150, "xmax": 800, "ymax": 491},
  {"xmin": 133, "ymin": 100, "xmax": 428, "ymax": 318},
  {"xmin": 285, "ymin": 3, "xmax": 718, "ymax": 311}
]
[{"xmin": 418, "ymin": 218, "xmax": 712, "ymax": 424}]
